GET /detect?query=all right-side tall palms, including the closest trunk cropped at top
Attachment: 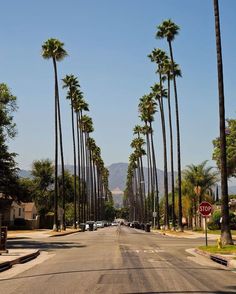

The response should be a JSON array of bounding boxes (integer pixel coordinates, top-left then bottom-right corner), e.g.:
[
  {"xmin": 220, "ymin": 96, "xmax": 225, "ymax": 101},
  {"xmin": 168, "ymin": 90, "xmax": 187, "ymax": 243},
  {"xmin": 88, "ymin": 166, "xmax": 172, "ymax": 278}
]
[{"xmin": 125, "ymin": 0, "xmax": 233, "ymax": 244}]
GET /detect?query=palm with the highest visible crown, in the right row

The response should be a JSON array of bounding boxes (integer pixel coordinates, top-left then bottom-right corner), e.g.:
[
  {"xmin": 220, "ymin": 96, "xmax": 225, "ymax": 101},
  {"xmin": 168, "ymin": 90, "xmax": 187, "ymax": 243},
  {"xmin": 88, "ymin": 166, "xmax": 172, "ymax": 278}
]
[{"xmin": 156, "ymin": 19, "xmax": 183, "ymax": 231}]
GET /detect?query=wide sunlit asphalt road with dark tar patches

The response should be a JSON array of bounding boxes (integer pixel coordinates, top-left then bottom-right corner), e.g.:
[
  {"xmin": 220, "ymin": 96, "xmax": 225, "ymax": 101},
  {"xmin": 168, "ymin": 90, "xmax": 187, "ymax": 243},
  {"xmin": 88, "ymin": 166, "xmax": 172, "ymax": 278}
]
[{"xmin": 0, "ymin": 227, "xmax": 236, "ymax": 294}]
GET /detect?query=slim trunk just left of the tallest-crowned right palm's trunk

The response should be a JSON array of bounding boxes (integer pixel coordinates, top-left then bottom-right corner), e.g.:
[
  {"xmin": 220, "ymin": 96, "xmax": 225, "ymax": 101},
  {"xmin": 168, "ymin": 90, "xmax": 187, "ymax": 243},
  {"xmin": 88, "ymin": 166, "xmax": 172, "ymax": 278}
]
[{"xmin": 167, "ymin": 75, "xmax": 175, "ymax": 228}]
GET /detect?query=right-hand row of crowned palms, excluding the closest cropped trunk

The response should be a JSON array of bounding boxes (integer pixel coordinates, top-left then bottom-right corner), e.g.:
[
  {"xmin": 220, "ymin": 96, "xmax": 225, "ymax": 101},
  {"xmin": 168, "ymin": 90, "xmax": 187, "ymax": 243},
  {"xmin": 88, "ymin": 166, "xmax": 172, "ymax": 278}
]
[{"xmin": 126, "ymin": 19, "xmax": 182, "ymax": 230}]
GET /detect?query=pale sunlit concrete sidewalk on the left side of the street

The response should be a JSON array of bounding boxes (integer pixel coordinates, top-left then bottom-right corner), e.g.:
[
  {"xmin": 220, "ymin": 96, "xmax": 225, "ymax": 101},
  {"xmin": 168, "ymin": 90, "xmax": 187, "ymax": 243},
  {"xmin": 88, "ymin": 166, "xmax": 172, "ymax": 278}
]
[{"xmin": 0, "ymin": 229, "xmax": 80, "ymax": 273}]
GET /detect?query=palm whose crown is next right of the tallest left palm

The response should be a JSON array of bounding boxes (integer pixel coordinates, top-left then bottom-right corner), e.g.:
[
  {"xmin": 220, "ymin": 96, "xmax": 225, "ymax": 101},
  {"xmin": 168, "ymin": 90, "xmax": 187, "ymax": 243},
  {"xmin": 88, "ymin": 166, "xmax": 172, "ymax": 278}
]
[{"xmin": 62, "ymin": 75, "xmax": 80, "ymax": 229}]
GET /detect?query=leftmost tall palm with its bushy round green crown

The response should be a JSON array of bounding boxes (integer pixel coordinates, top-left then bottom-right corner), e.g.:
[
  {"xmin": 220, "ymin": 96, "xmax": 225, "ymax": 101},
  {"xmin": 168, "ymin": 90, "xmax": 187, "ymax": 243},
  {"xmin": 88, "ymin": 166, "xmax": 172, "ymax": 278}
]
[{"xmin": 42, "ymin": 38, "xmax": 67, "ymax": 231}]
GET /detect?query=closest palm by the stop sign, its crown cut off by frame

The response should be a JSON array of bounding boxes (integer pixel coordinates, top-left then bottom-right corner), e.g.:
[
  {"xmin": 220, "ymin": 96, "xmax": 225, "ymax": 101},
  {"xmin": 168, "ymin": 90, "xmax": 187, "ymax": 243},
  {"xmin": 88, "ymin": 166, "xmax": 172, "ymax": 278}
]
[{"xmin": 214, "ymin": 0, "xmax": 233, "ymax": 244}]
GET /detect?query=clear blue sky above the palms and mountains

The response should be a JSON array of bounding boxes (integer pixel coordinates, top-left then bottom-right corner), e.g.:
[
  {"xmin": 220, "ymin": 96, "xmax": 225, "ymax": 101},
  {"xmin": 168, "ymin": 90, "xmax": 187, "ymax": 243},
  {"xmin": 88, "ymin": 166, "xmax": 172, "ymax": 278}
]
[{"xmin": 0, "ymin": 0, "xmax": 236, "ymax": 177}]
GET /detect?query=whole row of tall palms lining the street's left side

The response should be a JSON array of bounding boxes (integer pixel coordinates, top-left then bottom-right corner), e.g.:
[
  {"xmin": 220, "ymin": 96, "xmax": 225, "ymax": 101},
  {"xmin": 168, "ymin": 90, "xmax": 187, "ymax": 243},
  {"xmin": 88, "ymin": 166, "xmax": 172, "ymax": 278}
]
[{"xmin": 42, "ymin": 38, "xmax": 112, "ymax": 230}]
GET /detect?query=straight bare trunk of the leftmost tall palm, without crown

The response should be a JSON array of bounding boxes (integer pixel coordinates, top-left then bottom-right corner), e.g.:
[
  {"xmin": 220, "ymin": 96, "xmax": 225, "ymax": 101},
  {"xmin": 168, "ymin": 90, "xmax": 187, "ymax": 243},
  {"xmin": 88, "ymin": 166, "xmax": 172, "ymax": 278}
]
[{"xmin": 53, "ymin": 58, "xmax": 58, "ymax": 231}]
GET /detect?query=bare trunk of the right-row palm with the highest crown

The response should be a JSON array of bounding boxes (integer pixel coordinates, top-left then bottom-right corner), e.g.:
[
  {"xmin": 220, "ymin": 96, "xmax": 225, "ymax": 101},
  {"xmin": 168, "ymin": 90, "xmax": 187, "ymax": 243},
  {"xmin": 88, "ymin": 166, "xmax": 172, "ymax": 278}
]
[{"xmin": 168, "ymin": 40, "xmax": 183, "ymax": 231}]
